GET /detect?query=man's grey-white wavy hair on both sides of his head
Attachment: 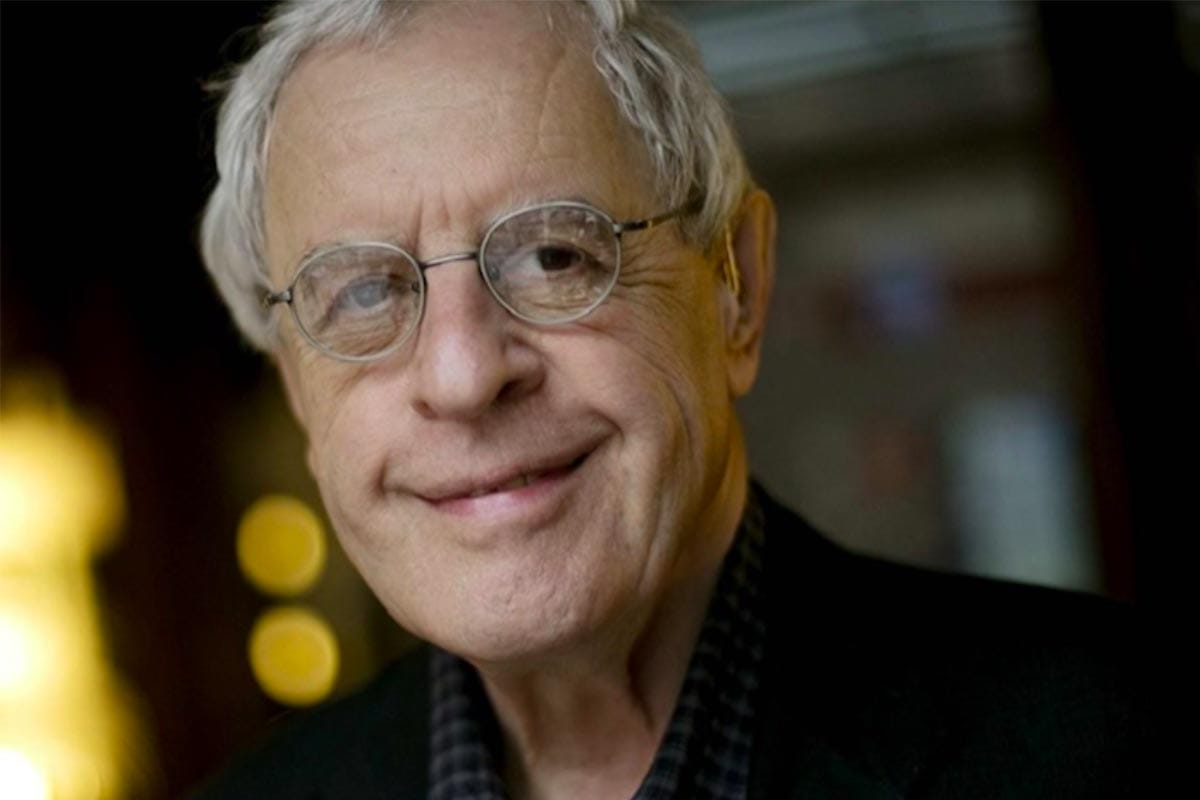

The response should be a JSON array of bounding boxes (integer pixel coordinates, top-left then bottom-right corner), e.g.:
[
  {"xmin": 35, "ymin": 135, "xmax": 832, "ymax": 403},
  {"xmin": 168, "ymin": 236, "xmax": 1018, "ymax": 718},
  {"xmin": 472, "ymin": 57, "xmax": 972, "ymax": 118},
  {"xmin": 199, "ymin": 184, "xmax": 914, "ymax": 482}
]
[{"xmin": 200, "ymin": 0, "xmax": 750, "ymax": 350}]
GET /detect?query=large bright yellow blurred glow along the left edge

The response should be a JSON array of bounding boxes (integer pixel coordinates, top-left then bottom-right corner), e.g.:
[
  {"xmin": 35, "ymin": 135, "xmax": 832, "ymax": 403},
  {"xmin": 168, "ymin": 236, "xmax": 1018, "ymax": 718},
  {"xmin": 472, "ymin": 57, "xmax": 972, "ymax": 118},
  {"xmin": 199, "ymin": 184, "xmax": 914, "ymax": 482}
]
[{"xmin": 0, "ymin": 383, "xmax": 149, "ymax": 800}]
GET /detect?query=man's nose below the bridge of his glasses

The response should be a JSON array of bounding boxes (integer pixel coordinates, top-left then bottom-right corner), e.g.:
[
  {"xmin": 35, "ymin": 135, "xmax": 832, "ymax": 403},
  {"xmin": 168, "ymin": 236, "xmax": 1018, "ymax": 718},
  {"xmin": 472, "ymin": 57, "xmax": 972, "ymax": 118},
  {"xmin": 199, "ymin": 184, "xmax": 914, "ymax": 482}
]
[{"xmin": 412, "ymin": 260, "xmax": 544, "ymax": 421}]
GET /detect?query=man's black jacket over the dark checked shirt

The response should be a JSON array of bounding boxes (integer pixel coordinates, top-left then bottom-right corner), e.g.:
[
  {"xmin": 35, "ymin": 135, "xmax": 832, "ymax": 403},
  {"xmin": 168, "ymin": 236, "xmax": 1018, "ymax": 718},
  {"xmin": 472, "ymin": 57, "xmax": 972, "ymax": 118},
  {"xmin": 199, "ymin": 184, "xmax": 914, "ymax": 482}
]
[{"xmin": 200, "ymin": 493, "xmax": 1153, "ymax": 800}]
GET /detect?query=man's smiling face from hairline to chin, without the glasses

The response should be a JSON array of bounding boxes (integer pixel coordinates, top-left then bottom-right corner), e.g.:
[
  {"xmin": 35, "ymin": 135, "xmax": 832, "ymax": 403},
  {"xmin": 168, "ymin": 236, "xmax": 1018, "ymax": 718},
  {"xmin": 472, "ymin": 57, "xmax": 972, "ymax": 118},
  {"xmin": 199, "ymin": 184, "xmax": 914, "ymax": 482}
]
[{"xmin": 266, "ymin": 4, "xmax": 744, "ymax": 661}]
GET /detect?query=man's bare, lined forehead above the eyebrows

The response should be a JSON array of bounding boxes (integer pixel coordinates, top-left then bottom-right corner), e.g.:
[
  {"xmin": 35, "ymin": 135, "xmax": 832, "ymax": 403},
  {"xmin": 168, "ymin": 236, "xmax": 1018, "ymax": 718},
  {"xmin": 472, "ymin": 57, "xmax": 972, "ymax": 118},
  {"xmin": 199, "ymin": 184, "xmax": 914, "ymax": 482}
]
[{"xmin": 265, "ymin": 4, "xmax": 654, "ymax": 271}]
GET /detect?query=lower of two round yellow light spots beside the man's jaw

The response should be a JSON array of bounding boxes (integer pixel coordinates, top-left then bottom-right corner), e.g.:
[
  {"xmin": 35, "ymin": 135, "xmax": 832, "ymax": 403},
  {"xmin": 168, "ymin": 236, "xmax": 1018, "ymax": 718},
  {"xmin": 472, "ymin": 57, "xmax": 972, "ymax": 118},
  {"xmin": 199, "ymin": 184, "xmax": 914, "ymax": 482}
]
[{"xmin": 250, "ymin": 606, "xmax": 338, "ymax": 705}]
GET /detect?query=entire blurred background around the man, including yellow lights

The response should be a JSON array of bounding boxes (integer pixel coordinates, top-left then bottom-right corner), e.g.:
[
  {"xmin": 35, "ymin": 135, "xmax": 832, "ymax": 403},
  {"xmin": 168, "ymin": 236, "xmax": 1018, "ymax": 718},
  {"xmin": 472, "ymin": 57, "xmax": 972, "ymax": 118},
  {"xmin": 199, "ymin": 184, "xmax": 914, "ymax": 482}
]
[{"xmin": 0, "ymin": 1, "xmax": 1200, "ymax": 799}]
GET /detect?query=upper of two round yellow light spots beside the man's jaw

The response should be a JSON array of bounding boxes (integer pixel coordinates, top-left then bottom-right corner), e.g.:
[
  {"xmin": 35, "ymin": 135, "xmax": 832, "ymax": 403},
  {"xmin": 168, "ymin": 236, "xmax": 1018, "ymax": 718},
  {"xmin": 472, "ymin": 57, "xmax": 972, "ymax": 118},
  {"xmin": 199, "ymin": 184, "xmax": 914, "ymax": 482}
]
[{"xmin": 238, "ymin": 494, "xmax": 325, "ymax": 597}]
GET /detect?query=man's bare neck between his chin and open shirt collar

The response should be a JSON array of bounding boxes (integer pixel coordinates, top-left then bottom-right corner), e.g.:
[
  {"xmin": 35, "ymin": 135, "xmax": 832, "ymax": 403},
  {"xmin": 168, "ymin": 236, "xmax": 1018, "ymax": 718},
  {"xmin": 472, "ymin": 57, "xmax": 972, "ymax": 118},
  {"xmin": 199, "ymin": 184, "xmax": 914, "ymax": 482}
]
[{"xmin": 475, "ymin": 438, "xmax": 746, "ymax": 800}]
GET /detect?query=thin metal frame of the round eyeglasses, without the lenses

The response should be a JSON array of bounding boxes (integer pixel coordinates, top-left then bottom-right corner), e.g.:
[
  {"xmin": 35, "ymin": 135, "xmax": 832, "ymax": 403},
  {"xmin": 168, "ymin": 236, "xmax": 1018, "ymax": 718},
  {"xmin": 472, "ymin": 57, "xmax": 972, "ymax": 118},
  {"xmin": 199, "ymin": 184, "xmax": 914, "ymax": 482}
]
[{"xmin": 263, "ymin": 198, "xmax": 701, "ymax": 363}]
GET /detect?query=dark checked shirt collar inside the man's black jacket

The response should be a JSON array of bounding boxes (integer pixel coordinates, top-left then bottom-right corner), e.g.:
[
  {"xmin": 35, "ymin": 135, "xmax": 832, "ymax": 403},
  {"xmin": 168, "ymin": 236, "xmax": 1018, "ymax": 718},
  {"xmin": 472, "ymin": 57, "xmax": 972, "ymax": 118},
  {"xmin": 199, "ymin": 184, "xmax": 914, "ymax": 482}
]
[{"xmin": 430, "ymin": 486, "xmax": 767, "ymax": 800}]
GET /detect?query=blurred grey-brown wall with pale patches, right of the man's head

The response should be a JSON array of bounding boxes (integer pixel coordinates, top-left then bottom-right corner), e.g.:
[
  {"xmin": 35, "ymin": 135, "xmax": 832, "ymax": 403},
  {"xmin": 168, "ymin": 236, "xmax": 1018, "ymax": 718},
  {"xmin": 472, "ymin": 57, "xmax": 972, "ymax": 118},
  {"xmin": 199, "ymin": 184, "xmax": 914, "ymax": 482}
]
[{"xmin": 676, "ymin": 1, "xmax": 1189, "ymax": 594}]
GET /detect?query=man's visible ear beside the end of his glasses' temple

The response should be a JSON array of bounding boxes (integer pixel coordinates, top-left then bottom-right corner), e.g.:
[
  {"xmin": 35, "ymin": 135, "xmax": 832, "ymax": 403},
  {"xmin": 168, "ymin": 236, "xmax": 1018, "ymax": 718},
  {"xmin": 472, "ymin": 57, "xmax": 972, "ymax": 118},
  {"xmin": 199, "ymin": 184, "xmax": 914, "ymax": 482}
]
[{"xmin": 721, "ymin": 188, "xmax": 775, "ymax": 397}]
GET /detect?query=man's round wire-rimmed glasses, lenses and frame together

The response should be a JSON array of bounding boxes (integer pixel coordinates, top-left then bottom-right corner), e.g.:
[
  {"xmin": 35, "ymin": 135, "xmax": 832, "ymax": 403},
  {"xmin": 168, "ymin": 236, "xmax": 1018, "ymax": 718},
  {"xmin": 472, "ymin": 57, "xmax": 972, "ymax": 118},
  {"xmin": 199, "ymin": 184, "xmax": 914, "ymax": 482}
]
[{"xmin": 263, "ymin": 200, "xmax": 697, "ymax": 361}]
